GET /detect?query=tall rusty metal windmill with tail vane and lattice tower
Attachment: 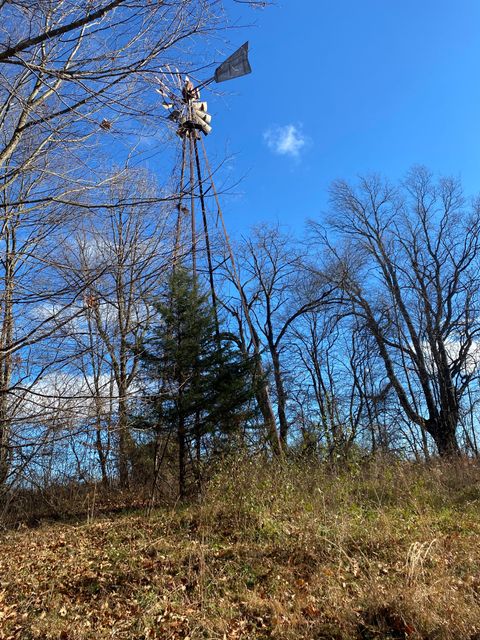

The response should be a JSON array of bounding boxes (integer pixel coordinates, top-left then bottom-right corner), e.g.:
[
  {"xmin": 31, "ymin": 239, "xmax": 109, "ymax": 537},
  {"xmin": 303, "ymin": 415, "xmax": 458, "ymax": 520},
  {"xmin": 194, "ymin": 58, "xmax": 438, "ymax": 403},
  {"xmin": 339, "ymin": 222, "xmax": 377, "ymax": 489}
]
[{"xmin": 157, "ymin": 42, "xmax": 282, "ymax": 454}]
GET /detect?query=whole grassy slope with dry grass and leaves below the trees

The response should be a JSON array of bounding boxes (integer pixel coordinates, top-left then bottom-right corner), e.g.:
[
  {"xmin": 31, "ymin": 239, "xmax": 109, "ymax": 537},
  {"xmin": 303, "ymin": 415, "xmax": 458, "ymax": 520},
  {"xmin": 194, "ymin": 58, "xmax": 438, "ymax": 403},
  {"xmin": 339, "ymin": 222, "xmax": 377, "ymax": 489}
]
[{"xmin": 0, "ymin": 461, "xmax": 480, "ymax": 640}]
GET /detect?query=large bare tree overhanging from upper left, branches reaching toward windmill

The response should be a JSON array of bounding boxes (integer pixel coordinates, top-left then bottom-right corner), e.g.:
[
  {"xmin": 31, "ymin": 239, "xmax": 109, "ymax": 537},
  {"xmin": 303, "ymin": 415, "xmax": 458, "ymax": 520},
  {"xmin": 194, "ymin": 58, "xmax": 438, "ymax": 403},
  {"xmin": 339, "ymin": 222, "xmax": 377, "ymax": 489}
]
[{"xmin": 0, "ymin": 0, "xmax": 240, "ymax": 490}]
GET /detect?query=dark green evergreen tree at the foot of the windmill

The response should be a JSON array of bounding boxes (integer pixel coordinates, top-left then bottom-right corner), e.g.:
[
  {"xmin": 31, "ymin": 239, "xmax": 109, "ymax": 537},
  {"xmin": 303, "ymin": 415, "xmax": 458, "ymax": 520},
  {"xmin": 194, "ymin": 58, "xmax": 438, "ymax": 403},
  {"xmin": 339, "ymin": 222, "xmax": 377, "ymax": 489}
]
[{"xmin": 142, "ymin": 267, "xmax": 253, "ymax": 497}]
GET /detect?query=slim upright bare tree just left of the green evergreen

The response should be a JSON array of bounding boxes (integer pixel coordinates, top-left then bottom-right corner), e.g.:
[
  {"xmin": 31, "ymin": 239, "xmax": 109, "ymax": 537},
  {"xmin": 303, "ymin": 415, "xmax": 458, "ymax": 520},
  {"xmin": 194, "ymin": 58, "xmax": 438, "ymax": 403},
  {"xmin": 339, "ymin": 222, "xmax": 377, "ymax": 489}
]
[{"xmin": 59, "ymin": 171, "xmax": 171, "ymax": 487}]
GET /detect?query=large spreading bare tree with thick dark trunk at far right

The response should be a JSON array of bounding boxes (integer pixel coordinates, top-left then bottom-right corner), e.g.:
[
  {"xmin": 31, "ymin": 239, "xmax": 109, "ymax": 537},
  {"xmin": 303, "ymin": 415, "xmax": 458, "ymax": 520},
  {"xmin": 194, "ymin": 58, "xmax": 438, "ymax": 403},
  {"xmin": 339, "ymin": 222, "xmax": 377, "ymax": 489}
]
[{"xmin": 313, "ymin": 168, "xmax": 480, "ymax": 456}]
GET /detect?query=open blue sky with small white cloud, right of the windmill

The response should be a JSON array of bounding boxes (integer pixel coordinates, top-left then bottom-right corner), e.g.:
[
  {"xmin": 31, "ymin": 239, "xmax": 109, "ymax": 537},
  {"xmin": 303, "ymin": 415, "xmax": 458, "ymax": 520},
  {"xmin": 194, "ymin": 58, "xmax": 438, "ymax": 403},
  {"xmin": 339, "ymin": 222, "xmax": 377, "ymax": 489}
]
[{"xmin": 194, "ymin": 0, "xmax": 480, "ymax": 233}]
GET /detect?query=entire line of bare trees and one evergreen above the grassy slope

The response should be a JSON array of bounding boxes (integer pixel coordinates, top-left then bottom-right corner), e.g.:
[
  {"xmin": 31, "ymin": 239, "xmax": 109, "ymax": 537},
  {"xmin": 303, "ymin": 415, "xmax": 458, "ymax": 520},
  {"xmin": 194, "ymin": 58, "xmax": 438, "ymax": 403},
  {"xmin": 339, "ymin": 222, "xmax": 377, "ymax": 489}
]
[{"xmin": 0, "ymin": 0, "xmax": 480, "ymax": 510}]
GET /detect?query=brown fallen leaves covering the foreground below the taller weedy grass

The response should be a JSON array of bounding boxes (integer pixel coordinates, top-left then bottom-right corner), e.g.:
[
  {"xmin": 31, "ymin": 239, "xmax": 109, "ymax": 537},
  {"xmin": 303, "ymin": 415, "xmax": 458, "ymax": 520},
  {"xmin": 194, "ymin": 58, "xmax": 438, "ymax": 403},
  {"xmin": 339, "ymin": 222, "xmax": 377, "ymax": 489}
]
[{"xmin": 0, "ymin": 496, "xmax": 480, "ymax": 640}]
